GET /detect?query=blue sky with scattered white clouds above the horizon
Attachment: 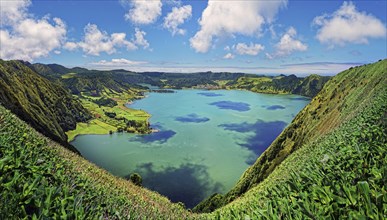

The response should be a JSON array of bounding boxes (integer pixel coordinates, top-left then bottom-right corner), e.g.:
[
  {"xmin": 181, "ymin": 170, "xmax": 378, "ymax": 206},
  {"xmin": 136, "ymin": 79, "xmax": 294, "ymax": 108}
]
[{"xmin": 0, "ymin": 0, "xmax": 387, "ymax": 75}]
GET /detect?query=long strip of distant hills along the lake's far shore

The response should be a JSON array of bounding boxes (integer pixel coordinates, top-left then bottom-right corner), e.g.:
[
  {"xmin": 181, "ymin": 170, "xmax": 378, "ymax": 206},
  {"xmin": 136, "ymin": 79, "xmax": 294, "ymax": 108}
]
[{"xmin": 31, "ymin": 63, "xmax": 330, "ymax": 97}]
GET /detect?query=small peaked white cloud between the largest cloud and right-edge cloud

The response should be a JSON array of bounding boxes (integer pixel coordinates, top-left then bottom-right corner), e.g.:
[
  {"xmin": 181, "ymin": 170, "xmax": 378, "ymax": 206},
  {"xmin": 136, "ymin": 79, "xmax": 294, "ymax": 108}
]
[{"xmin": 266, "ymin": 27, "xmax": 308, "ymax": 59}]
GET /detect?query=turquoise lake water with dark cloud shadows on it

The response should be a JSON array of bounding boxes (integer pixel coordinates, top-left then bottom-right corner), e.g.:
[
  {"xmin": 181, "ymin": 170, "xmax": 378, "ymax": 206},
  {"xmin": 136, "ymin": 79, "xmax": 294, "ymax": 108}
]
[{"xmin": 71, "ymin": 90, "xmax": 310, "ymax": 208}]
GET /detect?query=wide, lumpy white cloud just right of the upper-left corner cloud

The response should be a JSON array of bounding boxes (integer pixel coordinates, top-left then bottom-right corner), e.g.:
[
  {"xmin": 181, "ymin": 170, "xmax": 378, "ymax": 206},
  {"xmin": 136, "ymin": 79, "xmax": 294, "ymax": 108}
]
[{"xmin": 64, "ymin": 24, "xmax": 145, "ymax": 56}]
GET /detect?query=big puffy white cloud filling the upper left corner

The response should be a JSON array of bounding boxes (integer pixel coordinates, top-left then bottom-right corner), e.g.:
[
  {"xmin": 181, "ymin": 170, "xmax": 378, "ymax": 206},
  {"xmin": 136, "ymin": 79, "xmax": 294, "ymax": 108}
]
[{"xmin": 0, "ymin": 1, "xmax": 67, "ymax": 61}]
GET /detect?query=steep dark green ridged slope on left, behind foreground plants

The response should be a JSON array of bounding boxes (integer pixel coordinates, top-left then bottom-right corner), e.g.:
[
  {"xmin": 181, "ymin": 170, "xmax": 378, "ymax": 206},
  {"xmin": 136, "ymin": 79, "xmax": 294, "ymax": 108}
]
[{"xmin": 0, "ymin": 60, "xmax": 90, "ymax": 148}]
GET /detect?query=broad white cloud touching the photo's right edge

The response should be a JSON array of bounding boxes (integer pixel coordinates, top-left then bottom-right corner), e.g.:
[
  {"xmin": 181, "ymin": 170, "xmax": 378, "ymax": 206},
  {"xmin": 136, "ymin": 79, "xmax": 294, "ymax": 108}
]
[{"xmin": 313, "ymin": 2, "xmax": 386, "ymax": 47}]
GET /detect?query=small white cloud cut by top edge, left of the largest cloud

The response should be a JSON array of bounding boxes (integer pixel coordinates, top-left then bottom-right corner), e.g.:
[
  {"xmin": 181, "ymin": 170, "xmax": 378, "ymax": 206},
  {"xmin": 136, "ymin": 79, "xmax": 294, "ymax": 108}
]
[{"xmin": 125, "ymin": 0, "xmax": 162, "ymax": 24}]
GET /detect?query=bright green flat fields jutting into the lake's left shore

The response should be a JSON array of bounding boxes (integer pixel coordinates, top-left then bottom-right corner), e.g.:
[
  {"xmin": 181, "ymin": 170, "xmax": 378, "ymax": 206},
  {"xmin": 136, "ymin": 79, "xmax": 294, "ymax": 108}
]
[{"xmin": 66, "ymin": 89, "xmax": 150, "ymax": 142}]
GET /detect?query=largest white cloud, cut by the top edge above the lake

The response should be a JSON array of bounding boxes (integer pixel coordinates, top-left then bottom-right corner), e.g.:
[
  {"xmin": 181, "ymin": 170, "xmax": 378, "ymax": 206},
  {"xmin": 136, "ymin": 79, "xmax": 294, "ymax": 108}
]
[{"xmin": 190, "ymin": 0, "xmax": 287, "ymax": 53}]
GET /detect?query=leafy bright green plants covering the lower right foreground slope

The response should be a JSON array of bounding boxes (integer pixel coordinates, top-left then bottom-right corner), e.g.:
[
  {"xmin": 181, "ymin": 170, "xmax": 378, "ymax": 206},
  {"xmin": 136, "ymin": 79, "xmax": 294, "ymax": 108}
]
[{"xmin": 204, "ymin": 77, "xmax": 387, "ymax": 219}]
